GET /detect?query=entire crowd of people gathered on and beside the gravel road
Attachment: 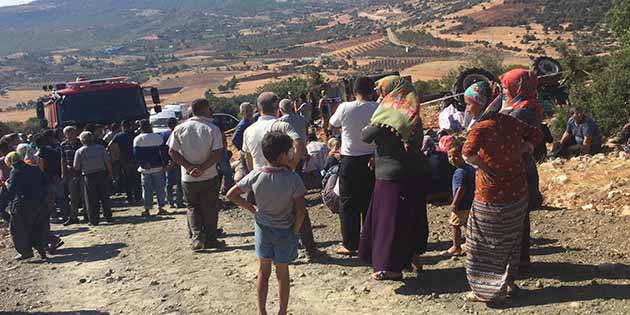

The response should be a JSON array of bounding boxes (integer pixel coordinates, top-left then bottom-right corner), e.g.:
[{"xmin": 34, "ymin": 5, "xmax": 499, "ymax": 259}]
[{"xmin": 0, "ymin": 65, "xmax": 630, "ymax": 314}]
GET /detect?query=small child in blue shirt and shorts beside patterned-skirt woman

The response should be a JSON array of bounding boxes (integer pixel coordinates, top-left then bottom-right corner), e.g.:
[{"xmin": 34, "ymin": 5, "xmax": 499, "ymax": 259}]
[{"xmin": 448, "ymin": 141, "xmax": 475, "ymax": 256}]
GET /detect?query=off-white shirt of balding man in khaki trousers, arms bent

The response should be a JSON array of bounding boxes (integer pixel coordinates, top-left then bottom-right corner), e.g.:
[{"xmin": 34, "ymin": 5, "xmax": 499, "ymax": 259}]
[{"xmin": 168, "ymin": 116, "xmax": 223, "ymax": 182}]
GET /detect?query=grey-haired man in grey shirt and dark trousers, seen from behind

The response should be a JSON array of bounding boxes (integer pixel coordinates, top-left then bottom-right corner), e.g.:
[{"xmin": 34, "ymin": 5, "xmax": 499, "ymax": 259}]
[{"xmin": 74, "ymin": 131, "xmax": 112, "ymax": 226}]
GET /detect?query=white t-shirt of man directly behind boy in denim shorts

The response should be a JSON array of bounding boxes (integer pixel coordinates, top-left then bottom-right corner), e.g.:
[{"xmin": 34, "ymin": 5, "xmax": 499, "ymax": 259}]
[{"xmin": 243, "ymin": 115, "xmax": 301, "ymax": 171}]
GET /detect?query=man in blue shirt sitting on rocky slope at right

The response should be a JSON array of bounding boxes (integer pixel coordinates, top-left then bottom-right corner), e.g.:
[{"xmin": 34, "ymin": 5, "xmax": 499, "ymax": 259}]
[{"xmin": 551, "ymin": 107, "xmax": 602, "ymax": 158}]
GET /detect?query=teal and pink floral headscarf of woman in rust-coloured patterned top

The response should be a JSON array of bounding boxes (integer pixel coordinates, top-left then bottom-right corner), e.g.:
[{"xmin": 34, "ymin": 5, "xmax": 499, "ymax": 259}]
[{"xmin": 464, "ymin": 81, "xmax": 503, "ymax": 121}]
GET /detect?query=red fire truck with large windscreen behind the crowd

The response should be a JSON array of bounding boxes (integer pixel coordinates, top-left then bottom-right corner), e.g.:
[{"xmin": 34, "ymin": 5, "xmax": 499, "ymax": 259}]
[{"xmin": 37, "ymin": 77, "xmax": 160, "ymax": 128}]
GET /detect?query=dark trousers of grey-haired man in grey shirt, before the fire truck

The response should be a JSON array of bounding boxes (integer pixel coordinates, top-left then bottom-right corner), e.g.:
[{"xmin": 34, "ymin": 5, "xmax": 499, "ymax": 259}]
[{"xmin": 83, "ymin": 172, "xmax": 112, "ymax": 225}]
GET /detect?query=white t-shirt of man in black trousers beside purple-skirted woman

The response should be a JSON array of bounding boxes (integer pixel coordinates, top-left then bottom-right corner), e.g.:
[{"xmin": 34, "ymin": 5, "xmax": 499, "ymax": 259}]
[{"xmin": 330, "ymin": 101, "xmax": 378, "ymax": 156}]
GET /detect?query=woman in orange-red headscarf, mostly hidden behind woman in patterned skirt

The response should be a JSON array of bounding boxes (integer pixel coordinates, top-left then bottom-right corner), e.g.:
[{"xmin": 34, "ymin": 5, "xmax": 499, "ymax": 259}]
[{"xmin": 500, "ymin": 69, "xmax": 547, "ymax": 267}]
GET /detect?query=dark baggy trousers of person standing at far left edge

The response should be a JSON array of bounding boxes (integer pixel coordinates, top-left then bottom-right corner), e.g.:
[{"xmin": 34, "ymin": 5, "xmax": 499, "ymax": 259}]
[{"xmin": 10, "ymin": 197, "xmax": 50, "ymax": 257}]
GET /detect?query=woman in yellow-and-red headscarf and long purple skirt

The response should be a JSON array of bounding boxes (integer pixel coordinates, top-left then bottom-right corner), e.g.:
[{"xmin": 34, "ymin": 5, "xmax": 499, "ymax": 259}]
[{"xmin": 359, "ymin": 76, "xmax": 430, "ymax": 280}]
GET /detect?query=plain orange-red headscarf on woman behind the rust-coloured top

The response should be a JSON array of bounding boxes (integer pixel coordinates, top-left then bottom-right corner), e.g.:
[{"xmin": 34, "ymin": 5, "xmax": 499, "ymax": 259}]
[{"xmin": 500, "ymin": 69, "xmax": 543, "ymax": 121}]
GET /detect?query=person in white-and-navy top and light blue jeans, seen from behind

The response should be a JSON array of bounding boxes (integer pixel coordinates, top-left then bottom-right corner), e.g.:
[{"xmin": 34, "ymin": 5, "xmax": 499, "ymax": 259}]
[{"xmin": 133, "ymin": 119, "xmax": 168, "ymax": 217}]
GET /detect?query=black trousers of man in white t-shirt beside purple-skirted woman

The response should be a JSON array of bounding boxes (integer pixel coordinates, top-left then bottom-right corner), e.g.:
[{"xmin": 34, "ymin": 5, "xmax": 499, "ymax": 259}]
[{"xmin": 339, "ymin": 155, "xmax": 374, "ymax": 250}]
